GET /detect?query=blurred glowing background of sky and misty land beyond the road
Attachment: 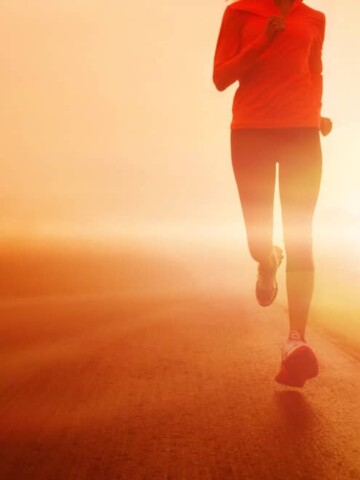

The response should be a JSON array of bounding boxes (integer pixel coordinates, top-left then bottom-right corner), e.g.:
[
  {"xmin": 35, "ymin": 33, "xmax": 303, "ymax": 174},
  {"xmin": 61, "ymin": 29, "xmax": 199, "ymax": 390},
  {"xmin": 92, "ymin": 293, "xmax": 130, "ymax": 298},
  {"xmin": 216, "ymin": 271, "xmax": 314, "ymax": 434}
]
[{"xmin": 0, "ymin": 0, "xmax": 360, "ymax": 350}]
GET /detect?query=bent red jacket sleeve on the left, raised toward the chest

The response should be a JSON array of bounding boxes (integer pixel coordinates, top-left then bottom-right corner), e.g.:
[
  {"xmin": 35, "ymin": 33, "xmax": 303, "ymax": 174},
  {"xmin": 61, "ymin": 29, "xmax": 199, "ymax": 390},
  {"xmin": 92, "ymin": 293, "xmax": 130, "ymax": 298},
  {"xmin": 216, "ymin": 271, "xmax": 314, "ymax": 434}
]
[{"xmin": 213, "ymin": 7, "xmax": 269, "ymax": 91}]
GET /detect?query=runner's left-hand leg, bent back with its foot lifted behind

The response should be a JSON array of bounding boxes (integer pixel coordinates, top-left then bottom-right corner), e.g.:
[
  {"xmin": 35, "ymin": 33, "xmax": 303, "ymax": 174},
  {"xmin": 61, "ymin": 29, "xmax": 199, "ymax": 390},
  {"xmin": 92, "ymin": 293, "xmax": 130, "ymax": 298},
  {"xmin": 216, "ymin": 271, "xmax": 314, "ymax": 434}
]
[{"xmin": 231, "ymin": 129, "xmax": 276, "ymax": 265}]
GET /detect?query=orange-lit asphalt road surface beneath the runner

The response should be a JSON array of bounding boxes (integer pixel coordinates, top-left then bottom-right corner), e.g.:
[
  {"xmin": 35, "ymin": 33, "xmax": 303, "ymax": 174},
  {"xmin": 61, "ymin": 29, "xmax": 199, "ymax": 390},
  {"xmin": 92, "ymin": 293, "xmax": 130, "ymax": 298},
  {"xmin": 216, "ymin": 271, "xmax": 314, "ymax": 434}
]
[{"xmin": 0, "ymin": 242, "xmax": 360, "ymax": 480}]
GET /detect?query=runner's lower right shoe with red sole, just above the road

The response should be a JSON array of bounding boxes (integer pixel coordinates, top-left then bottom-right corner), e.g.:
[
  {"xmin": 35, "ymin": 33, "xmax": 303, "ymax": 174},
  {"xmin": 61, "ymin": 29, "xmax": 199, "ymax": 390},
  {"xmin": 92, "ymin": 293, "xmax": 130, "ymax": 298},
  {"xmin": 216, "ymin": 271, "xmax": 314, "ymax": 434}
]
[{"xmin": 275, "ymin": 330, "xmax": 319, "ymax": 387}]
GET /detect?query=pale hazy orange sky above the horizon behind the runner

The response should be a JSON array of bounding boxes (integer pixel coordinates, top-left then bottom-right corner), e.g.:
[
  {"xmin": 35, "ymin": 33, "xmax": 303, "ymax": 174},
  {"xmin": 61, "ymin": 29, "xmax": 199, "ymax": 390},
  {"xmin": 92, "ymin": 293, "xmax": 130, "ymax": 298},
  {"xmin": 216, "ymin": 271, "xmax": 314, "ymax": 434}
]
[{"xmin": 0, "ymin": 0, "xmax": 360, "ymax": 236}]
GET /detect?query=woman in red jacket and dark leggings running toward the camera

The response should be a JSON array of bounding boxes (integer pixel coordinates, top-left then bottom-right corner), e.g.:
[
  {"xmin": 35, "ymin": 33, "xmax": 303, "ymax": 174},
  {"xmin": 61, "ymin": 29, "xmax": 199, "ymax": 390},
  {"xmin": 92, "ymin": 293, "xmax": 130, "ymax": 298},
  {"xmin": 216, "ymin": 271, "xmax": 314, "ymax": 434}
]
[{"xmin": 213, "ymin": 0, "xmax": 332, "ymax": 387}]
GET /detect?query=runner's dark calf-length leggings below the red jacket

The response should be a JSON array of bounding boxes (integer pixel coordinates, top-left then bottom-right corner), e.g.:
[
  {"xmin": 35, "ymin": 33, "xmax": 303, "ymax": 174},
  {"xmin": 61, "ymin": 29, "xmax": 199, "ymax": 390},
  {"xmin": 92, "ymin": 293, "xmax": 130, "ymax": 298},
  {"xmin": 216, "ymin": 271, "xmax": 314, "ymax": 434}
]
[{"xmin": 231, "ymin": 128, "xmax": 322, "ymax": 271}]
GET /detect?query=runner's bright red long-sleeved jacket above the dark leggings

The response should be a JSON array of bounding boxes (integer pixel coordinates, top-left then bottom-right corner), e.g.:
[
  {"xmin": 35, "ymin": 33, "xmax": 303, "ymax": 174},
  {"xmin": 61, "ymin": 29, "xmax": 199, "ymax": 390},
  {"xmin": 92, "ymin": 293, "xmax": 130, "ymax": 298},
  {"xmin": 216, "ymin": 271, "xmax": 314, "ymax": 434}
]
[{"xmin": 213, "ymin": 0, "xmax": 325, "ymax": 129}]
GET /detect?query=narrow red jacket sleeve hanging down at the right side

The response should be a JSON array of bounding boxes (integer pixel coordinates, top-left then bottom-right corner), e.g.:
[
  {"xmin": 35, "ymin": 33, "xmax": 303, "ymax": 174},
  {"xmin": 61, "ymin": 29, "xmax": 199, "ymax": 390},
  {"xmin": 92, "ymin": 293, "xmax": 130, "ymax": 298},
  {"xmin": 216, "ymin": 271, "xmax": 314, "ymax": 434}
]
[{"xmin": 309, "ymin": 14, "xmax": 325, "ymax": 114}]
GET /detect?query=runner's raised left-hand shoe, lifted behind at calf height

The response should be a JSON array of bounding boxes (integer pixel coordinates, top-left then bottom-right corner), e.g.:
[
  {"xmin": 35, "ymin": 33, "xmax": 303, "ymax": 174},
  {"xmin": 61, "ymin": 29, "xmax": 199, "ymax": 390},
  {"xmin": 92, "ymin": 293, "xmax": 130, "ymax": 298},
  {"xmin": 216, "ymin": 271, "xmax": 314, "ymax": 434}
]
[{"xmin": 255, "ymin": 247, "xmax": 283, "ymax": 307}]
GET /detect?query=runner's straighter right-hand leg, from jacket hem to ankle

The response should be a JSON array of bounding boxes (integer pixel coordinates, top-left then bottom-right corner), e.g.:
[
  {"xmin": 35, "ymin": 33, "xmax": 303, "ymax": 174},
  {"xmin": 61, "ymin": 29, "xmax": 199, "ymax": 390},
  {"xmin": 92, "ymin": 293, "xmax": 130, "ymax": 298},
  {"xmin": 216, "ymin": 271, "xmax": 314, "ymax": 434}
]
[{"xmin": 279, "ymin": 128, "xmax": 322, "ymax": 338}]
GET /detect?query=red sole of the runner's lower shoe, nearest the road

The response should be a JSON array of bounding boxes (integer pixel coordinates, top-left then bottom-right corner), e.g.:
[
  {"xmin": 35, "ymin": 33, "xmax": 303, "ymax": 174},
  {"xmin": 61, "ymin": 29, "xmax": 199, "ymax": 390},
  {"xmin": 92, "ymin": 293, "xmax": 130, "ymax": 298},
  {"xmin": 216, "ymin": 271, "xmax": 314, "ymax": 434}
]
[{"xmin": 275, "ymin": 345, "xmax": 319, "ymax": 387}]
